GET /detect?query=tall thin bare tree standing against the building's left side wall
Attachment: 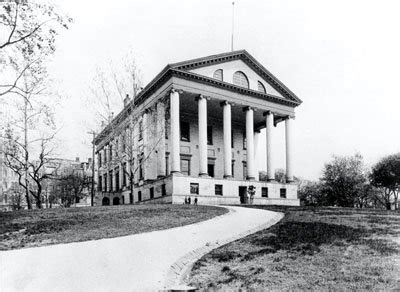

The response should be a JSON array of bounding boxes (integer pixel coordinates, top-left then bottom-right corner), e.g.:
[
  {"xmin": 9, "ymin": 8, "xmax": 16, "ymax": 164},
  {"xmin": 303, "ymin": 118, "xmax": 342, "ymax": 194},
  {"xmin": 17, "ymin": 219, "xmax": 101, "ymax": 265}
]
[{"xmin": 88, "ymin": 52, "xmax": 167, "ymax": 203}]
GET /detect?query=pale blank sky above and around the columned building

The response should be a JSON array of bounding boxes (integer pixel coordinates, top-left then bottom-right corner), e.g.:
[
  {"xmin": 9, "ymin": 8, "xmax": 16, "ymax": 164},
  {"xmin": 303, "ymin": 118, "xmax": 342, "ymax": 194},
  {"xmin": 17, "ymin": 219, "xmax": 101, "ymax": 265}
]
[{"xmin": 44, "ymin": 0, "xmax": 400, "ymax": 179}]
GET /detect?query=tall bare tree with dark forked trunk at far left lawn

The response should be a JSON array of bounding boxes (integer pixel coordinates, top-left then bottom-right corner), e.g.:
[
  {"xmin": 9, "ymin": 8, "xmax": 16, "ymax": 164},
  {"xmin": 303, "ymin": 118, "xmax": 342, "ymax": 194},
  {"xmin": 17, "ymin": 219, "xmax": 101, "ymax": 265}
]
[{"xmin": 2, "ymin": 55, "xmax": 55, "ymax": 209}]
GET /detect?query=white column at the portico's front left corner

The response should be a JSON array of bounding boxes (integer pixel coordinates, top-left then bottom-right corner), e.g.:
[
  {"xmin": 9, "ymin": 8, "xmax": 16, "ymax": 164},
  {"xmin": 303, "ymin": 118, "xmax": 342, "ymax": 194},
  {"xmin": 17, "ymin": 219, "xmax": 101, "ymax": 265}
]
[{"xmin": 170, "ymin": 89, "xmax": 181, "ymax": 173}]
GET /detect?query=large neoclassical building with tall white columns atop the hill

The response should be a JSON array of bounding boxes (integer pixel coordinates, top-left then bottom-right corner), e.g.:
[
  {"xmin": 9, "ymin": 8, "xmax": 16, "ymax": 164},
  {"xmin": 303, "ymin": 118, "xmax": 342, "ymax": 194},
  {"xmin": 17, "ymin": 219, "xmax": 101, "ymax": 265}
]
[{"xmin": 95, "ymin": 50, "xmax": 301, "ymax": 205}]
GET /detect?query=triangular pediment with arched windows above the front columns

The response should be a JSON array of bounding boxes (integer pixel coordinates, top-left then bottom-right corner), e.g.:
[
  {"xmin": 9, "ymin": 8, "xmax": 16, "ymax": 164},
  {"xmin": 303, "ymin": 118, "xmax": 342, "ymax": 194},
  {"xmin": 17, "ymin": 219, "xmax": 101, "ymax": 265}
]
[{"xmin": 170, "ymin": 50, "xmax": 301, "ymax": 104}]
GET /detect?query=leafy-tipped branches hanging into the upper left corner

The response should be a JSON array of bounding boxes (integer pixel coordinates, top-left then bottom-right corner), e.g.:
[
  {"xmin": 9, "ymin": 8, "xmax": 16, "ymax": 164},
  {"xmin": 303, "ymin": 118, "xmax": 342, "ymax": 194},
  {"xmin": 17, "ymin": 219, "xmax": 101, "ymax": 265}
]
[{"xmin": 0, "ymin": 0, "xmax": 72, "ymax": 96}]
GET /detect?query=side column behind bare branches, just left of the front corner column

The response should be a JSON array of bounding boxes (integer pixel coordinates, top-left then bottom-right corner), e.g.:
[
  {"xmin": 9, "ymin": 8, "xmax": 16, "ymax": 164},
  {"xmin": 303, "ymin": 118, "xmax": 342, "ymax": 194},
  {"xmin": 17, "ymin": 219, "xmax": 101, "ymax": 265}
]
[{"xmin": 156, "ymin": 101, "xmax": 166, "ymax": 177}]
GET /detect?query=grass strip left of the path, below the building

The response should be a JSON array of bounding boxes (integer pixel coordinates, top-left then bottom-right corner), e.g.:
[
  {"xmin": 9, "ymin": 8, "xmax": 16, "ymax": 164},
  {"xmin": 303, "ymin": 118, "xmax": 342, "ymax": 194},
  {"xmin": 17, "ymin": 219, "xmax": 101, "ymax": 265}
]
[{"xmin": 0, "ymin": 204, "xmax": 227, "ymax": 250}]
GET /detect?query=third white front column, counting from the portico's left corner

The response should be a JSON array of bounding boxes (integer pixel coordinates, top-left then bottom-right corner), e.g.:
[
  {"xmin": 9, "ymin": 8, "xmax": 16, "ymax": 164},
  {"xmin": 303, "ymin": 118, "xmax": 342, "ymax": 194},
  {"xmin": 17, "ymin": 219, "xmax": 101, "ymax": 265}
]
[{"xmin": 222, "ymin": 101, "xmax": 232, "ymax": 178}]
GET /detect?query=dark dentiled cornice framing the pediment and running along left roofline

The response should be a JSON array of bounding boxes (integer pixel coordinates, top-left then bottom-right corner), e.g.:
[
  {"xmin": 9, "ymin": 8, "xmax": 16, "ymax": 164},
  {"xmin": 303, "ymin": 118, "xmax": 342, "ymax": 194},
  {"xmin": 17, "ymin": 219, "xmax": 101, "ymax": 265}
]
[{"xmin": 95, "ymin": 50, "xmax": 302, "ymax": 144}]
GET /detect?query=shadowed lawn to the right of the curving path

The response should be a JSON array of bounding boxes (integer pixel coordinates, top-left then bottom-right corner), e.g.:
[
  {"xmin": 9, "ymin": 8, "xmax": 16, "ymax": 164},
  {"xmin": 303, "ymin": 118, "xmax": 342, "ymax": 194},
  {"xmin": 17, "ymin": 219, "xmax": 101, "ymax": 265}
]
[{"xmin": 188, "ymin": 206, "xmax": 400, "ymax": 290}]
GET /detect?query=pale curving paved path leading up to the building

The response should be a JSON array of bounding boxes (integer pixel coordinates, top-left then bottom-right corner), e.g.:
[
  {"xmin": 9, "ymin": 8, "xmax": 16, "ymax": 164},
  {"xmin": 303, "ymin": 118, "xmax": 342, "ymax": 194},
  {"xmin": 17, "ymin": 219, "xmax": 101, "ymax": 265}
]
[{"xmin": 0, "ymin": 207, "xmax": 283, "ymax": 292}]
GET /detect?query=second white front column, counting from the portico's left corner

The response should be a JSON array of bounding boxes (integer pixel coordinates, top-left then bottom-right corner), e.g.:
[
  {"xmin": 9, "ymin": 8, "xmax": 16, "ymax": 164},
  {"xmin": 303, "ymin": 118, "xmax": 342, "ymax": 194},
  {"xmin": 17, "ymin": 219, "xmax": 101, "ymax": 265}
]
[{"xmin": 197, "ymin": 95, "xmax": 208, "ymax": 176}]
